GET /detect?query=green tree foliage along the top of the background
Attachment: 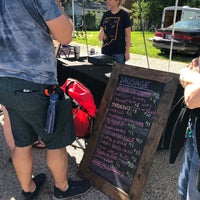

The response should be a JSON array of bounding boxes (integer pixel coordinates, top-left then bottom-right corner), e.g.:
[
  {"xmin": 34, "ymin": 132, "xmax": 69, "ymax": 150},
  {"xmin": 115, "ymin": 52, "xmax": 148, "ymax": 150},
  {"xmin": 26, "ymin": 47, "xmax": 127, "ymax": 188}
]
[{"xmin": 63, "ymin": 0, "xmax": 200, "ymax": 31}]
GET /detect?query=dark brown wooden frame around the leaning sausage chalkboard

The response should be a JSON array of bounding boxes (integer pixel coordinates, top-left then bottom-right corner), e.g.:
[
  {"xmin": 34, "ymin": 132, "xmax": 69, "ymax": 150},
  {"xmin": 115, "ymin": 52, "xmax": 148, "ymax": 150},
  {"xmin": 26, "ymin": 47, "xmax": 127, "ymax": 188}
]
[{"xmin": 79, "ymin": 64, "xmax": 179, "ymax": 200}]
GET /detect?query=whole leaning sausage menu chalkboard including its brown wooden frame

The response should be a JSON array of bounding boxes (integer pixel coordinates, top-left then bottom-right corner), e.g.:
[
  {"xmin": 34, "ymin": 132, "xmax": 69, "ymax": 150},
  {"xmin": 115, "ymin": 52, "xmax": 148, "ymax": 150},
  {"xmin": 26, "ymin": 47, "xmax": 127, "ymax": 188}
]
[{"xmin": 80, "ymin": 65, "xmax": 179, "ymax": 200}]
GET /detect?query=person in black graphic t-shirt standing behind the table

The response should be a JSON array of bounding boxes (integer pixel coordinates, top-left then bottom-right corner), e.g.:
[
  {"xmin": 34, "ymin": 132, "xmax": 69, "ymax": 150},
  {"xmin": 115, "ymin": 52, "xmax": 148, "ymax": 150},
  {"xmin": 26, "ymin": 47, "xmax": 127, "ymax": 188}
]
[{"xmin": 98, "ymin": 0, "xmax": 131, "ymax": 64}]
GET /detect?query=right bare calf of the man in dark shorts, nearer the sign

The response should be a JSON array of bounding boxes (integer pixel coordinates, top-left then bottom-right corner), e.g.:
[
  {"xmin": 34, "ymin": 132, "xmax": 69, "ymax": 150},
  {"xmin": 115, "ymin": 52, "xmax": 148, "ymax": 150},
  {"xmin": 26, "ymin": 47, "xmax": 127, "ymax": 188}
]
[{"xmin": 47, "ymin": 148, "xmax": 68, "ymax": 191}]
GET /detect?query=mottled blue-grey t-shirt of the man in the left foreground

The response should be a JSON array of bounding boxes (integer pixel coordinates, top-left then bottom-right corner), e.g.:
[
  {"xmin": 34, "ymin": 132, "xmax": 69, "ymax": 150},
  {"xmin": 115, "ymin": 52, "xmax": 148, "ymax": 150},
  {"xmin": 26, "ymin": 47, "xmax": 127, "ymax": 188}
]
[{"xmin": 0, "ymin": 0, "xmax": 61, "ymax": 84}]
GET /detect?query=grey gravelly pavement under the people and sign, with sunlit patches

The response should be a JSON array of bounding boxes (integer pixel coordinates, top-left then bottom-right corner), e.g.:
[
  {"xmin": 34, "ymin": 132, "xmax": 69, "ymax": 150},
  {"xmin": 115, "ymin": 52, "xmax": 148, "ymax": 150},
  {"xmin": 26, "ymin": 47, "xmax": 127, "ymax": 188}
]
[{"xmin": 0, "ymin": 43, "xmax": 188, "ymax": 200}]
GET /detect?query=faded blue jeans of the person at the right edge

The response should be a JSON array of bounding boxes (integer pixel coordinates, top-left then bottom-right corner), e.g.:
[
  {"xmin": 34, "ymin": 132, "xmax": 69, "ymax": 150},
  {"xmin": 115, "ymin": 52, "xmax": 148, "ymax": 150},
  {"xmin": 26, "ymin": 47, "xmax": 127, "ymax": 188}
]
[{"xmin": 178, "ymin": 124, "xmax": 200, "ymax": 200}]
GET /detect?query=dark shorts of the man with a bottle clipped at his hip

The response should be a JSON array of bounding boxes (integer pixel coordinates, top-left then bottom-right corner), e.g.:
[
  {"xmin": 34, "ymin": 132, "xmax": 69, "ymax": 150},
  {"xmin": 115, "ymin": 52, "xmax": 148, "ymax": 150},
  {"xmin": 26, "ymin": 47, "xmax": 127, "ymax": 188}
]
[{"xmin": 0, "ymin": 77, "xmax": 76, "ymax": 149}]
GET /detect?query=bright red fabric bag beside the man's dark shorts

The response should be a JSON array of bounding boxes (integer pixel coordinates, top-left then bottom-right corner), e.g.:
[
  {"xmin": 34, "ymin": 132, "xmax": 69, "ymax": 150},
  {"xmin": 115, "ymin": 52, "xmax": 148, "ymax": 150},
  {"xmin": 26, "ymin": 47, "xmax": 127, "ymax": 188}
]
[{"xmin": 61, "ymin": 78, "xmax": 96, "ymax": 137}]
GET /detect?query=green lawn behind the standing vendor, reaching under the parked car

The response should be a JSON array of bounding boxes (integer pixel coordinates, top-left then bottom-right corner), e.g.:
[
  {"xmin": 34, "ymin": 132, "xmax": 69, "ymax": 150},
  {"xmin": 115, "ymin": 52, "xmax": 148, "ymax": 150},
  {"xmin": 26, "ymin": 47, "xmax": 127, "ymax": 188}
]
[{"xmin": 73, "ymin": 31, "xmax": 195, "ymax": 63}]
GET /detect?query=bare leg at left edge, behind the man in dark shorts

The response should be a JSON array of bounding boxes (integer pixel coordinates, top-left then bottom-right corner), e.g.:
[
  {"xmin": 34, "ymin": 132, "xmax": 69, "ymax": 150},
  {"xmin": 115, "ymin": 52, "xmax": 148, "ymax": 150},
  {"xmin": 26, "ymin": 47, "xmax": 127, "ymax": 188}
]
[{"xmin": 1, "ymin": 105, "xmax": 15, "ymax": 154}]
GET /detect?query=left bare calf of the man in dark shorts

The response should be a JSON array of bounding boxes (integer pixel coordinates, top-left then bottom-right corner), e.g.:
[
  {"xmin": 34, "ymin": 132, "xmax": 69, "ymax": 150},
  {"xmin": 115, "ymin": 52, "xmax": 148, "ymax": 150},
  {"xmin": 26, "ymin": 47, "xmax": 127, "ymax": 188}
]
[{"xmin": 12, "ymin": 145, "xmax": 36, "ymax": 192}]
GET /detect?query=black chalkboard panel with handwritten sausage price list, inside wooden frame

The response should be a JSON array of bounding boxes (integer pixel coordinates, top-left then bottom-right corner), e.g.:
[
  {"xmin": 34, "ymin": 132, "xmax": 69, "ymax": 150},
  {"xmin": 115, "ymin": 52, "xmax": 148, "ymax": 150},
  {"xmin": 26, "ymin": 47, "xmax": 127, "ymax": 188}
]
[{"xmin": 89, "ymin": 75, "xmax": 165, "ymax": 192}]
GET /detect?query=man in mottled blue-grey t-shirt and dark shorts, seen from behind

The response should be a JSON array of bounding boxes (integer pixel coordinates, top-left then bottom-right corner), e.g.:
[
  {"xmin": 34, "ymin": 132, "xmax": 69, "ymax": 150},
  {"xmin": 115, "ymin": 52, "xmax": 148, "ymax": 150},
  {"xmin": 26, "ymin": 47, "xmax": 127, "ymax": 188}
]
[{"xmin": 0, "ymin": 0, "xmax": 91, "ymax": 200}]
